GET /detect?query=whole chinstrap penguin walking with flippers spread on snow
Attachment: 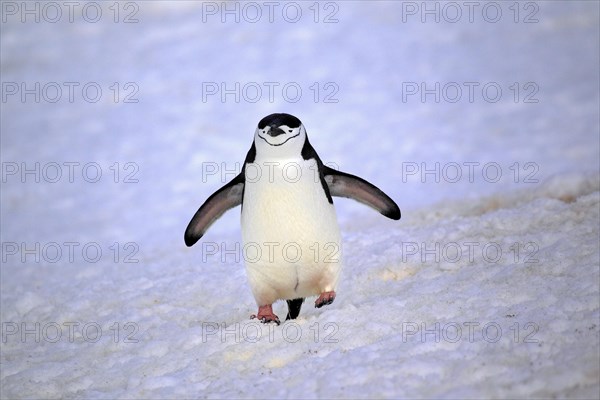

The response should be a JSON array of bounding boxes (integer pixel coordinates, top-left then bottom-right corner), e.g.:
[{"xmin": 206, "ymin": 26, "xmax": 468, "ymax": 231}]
[{"xmin": 184, "ymin": 114, "xmax": 400, "ymax": 324}]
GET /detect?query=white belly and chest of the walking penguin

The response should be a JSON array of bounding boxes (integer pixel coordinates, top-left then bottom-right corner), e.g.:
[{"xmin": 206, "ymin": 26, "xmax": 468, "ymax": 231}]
[{"xmin": 242, "ymin": 160, "xmax": 342, "ymax": 306}]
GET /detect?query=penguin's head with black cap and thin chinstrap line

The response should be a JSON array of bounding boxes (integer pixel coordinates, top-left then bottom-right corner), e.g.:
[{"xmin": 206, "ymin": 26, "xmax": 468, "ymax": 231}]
[{"xmin": 254, "ymin": 114, "xmax": 306, "ymax": 158}]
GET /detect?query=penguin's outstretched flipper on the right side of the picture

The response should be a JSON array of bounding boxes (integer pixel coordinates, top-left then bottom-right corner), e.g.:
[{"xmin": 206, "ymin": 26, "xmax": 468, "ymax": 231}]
[{"xmin": 323, "ymin": 166, "xmax": 400, "ymax": 220}]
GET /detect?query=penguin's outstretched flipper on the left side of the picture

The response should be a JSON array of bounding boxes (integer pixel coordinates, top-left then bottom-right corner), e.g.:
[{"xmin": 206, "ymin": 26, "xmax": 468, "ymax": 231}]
[{"xmin": 184, "ymin": 172, "xmax": 245, "ymax": 247}]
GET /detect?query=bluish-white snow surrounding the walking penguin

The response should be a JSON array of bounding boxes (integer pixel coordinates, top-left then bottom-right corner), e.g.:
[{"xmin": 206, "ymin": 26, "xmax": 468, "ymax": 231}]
[{"xmin": 0, "ymin": 1, "xmax": 600, "ymax": 398}]
